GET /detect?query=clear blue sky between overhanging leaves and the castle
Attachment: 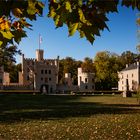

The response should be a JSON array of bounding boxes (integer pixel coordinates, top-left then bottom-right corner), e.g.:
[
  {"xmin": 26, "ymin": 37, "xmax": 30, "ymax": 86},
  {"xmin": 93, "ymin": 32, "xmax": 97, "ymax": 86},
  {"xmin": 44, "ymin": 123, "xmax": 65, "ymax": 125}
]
[{"xmin": 16, "ymin": 6, "xmax": 137, "ymax": 63}]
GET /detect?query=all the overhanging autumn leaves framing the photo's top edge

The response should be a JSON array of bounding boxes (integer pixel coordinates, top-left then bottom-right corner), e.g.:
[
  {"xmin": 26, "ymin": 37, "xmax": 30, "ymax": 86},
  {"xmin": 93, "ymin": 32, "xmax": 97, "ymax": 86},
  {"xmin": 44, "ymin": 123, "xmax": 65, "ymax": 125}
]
[{"xmin": 0, "ymin": 0, "xmax": 140, "ymax": 46}]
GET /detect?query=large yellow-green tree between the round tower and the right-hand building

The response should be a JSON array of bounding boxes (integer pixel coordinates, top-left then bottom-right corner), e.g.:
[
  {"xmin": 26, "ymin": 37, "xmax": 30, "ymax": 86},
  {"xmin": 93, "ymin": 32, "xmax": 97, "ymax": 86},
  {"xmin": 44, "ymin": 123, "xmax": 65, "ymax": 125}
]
[{"xmin": 94, "ymin": 51, "xmax": 119, "ymax": 90}]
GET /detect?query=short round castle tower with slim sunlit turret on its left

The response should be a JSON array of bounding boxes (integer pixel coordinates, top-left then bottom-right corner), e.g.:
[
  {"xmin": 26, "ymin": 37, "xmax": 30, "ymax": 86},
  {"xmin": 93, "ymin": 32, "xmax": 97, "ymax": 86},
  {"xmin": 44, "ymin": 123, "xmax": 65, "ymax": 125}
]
[{"xmin": 78, "ymin": 68, "xmax": 95, "ymax": 91}]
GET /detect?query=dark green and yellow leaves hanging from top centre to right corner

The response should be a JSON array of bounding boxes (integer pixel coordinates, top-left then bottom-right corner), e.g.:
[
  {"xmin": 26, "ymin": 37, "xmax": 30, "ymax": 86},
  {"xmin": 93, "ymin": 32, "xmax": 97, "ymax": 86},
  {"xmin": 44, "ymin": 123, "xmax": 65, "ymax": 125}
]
[{"xmin": 49, "ymin": 0, "xmax": 140, "ymax": 43}]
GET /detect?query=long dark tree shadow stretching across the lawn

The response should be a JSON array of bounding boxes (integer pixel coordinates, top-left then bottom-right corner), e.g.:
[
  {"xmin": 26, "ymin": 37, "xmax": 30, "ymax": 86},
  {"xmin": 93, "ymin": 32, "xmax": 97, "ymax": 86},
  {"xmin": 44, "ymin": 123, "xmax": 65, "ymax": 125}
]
[{"xmin": 0, "ymin": 95, "xmax": 140, "ymax": 123}]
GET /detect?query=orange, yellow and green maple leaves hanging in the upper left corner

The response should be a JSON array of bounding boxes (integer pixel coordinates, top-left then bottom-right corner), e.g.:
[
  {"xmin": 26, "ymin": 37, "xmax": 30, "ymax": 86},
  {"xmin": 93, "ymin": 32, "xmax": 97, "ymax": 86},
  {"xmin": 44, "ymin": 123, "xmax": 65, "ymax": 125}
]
[{"xmin": 0, "ymin": 0, "xmax": 44, "ymax": 65}]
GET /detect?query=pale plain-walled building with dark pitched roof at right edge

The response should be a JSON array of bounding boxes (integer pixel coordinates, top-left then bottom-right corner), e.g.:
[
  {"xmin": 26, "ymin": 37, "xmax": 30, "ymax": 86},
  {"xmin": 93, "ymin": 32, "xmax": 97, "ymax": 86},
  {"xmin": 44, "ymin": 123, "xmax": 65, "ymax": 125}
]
[{"xmin": 118, "ymin": 62, "xmax": 140, "ymax": 91}]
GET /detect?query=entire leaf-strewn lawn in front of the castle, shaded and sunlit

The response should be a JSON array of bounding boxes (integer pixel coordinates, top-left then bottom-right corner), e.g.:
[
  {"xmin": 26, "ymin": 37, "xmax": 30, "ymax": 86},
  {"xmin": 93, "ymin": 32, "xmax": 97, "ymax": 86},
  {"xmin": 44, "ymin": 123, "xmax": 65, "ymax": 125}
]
[{"xmin": 0, "ymin": 94, "xmax": 140, "ymax": 140}]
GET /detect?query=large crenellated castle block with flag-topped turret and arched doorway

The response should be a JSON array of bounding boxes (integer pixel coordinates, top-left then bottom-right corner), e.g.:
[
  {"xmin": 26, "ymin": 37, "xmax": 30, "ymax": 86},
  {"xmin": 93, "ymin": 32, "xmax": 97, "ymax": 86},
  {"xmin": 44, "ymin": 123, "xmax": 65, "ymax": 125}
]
[{"xmin": 19, "ymin": 49, "xmax": 59, "ymax": 93}]
